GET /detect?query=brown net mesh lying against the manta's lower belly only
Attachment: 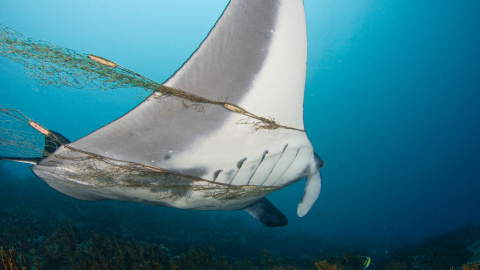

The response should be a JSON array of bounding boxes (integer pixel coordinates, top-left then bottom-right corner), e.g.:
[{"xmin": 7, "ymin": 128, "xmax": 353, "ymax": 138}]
[{"xmin": 43, "ymin": 145, "xmax": 281, "ymax": 202}]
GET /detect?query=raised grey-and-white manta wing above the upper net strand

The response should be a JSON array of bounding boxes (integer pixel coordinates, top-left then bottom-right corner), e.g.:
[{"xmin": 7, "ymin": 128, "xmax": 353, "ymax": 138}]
[{"xmin": 165, "ymin": 0, "xmax": 307, "ymax": 130}]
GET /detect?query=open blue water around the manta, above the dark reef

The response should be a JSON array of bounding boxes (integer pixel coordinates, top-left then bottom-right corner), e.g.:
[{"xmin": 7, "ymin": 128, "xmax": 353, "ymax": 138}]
[{"xmin": 0, "ymin": 0, "xmax": 480, "ymax": 268}]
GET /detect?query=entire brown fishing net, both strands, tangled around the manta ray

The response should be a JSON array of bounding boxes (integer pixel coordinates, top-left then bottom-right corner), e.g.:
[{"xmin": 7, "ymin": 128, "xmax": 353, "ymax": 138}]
[{"xmin": 0, "ymin": 24, "xmax": 286, "ymax": 205}]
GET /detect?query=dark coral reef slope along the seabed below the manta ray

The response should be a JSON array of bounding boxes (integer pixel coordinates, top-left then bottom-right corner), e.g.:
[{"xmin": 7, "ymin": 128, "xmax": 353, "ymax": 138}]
[{"xmin": 0, "ymin": 162, "xmax": 480, "ymax": 270}]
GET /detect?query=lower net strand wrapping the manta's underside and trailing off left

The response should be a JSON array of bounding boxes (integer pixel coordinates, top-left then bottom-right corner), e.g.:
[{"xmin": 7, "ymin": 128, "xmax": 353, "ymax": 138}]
[{"xmin": 0, "ymin": 108, "xmax": 281, "ymax": 205}]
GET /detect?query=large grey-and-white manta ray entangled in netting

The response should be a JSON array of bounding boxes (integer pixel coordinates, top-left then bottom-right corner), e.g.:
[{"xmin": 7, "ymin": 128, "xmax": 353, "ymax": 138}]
[{"xmin": 3, "ymin": 0, "xmax": 323, "ymax": 226}]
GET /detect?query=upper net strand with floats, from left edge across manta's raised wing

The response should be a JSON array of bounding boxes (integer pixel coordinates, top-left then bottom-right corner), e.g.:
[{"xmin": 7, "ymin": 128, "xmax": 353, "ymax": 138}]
[{"xmin": 0, "ymin": 23, "xmax": 296, "ymax": 132}]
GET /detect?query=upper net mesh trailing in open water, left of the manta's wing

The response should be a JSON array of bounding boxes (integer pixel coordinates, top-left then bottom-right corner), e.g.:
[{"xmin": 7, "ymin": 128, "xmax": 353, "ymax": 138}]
[{"xmin": 0, "ymin": 23, "xmax": 160, "ymax": 95}]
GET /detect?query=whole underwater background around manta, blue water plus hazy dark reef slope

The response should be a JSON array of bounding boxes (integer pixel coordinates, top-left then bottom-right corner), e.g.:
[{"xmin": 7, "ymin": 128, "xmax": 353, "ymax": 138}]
[{"xmin": 0, "ymin": 0, "xmax": 480, "ymax": 269}]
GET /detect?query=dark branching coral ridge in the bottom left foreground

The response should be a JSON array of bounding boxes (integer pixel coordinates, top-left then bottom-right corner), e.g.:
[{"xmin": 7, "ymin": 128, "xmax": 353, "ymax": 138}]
[{"xmin": 0, "ymin": 222, "xmax": 312, "ymax": 270}]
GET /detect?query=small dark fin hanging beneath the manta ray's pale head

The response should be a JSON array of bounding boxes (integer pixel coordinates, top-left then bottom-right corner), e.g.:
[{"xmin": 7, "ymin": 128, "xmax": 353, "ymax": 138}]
[{"xmin": 243, "ymin": 198, "xmax": 288, "ymax": 227}]
